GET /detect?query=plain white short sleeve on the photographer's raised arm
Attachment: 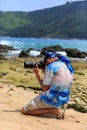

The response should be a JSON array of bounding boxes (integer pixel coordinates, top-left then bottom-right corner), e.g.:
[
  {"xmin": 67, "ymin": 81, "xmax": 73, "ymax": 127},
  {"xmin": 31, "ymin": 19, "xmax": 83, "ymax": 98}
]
[{"xmin": 43, "ymin": 70, "xmax": 53, "ymax": 85}]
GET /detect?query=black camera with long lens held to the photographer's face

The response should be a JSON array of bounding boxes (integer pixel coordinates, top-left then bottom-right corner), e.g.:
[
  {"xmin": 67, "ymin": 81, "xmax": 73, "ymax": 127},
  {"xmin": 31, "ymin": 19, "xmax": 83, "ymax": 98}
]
[{"xmin": 24, "ymin": 61, "xmax": 45, "ymax": 69}]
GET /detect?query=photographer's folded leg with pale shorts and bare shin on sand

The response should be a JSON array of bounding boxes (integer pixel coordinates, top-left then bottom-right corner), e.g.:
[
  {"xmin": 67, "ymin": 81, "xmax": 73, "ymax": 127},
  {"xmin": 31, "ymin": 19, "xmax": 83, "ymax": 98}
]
[{"xmin": 21, "ymin": 96, "xmax": 64, "ymax": 118}]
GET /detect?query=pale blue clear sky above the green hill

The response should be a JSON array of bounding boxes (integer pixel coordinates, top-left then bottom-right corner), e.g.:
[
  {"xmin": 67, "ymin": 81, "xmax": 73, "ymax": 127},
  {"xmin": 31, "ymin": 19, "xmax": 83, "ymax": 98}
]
[{"xmin": 0, "ymin": 0, "xmax": 80, "ymax": 12}]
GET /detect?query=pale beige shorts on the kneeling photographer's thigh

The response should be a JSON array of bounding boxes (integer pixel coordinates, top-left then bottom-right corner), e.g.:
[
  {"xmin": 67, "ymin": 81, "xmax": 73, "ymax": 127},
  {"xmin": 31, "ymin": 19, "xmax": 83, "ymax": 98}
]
[{"xmin": 24, "ymin": 96, "xmax": 53, "ymax": 111}]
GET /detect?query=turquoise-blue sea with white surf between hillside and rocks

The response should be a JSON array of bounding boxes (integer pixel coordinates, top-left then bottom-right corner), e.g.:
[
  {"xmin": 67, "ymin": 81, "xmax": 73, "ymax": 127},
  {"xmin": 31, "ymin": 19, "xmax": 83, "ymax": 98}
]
[{"xmin": 0, "ymin": 37, "xmax": 87, "ymax": 57}]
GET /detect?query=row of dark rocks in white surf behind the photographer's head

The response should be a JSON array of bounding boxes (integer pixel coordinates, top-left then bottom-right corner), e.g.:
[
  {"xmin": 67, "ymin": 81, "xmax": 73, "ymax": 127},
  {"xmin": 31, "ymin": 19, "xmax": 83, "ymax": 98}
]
[{"xmin": 19, "ymin": 46, "xmax": 87, "ymax": 58}]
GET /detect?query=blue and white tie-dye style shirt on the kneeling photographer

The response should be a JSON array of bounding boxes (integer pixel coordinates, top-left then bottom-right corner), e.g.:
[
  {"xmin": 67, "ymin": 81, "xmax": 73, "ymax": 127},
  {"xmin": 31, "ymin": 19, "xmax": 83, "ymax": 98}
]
[{"xmin": 40, "ymin": 60, "xmax": 73, "ymax": 108}]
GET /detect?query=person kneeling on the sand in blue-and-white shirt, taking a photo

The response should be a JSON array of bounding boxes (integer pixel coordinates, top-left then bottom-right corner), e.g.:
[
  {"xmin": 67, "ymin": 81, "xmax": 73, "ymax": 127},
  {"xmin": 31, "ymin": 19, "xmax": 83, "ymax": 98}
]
[{"xmin": 21, "ymin": 52, "xmax": 74, "ymax": 119}]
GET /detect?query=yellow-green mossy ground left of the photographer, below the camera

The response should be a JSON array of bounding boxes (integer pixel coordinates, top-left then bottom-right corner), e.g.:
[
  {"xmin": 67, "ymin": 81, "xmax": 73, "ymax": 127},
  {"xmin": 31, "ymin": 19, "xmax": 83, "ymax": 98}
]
[{"xmin": 0, "ymin": 58, "xmax": 41, "ymax": 89}]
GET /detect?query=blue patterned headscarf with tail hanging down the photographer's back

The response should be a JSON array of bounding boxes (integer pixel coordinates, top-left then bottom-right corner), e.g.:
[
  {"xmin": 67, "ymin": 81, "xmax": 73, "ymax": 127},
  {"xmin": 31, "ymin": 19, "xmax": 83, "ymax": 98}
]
[{"xmin": 44, "ymin": 51, "xmax": 74, "ymax": 74}]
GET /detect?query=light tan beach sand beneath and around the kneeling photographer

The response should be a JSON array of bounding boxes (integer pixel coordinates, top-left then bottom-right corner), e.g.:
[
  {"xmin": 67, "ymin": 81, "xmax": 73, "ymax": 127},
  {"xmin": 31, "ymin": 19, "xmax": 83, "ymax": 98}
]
[{"xmin": 0, "ymin": 83, "xmax": 87, "ymax": 130}]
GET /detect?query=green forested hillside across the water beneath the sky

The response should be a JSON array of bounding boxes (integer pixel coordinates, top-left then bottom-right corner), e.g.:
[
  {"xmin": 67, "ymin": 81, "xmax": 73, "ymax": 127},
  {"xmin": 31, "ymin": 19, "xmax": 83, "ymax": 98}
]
[{"xmin": 0, "ymin": 0, "xmax": 87, "ymax": 39}]
